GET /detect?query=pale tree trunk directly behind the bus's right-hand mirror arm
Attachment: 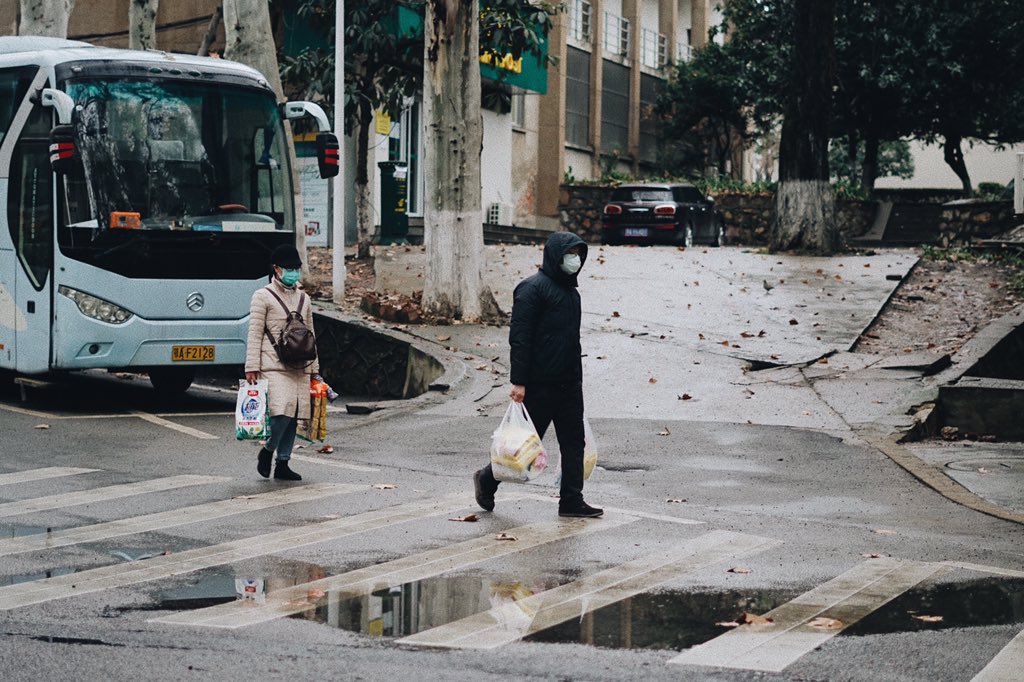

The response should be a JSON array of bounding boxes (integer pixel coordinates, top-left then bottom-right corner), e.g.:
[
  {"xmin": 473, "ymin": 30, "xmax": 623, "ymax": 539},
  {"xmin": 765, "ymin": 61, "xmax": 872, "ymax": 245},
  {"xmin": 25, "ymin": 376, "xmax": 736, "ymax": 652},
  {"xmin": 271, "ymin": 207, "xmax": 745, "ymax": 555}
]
[{"xmin": 223, "ymin": 0, "xmax": 309, "ymax": 280}]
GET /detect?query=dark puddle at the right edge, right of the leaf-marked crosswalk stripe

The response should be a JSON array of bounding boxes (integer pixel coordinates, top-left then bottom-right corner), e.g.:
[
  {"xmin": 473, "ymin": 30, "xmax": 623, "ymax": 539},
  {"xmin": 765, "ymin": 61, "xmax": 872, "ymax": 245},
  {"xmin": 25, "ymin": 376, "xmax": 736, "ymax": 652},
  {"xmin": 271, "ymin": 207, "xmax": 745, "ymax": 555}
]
[{"xmin": 843, "ymin": 578, "xmax": 1024, "ymax": 637}]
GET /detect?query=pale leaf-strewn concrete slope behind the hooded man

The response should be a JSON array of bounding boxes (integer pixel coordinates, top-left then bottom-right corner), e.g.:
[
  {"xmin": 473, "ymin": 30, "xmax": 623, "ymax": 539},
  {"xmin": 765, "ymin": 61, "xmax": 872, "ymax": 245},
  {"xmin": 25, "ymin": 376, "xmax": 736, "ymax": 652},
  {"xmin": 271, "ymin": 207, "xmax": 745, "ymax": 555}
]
[{"xmin": 354, "ymin": 241, "xmax": 1024, "ymax": 522}]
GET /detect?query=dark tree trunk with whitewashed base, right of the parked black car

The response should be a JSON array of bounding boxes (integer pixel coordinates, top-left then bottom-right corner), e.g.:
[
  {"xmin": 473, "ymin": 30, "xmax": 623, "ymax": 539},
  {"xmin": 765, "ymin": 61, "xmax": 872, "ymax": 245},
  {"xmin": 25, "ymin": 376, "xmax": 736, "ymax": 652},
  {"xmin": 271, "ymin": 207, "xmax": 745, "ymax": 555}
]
[{"xmin": 771, "ymin": 0, "xmax": 840, "ymax": 255}]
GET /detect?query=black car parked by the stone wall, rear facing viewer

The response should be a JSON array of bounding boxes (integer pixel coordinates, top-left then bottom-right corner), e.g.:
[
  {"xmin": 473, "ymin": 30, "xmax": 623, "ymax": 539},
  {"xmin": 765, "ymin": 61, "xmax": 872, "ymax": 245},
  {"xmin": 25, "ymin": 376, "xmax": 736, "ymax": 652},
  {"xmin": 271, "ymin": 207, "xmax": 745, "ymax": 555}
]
[{"xmin": 601, "ymin": 183, "xmax": 725, "ymax": 247}]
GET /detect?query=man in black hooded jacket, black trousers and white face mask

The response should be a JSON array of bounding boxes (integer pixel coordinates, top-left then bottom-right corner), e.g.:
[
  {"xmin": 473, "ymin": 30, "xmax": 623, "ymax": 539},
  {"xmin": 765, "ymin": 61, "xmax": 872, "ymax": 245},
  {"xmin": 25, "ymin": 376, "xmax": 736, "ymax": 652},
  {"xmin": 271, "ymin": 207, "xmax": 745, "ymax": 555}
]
[{"xmin": 473, "ymin": 232, "xmax": 603, "ymax": 518}]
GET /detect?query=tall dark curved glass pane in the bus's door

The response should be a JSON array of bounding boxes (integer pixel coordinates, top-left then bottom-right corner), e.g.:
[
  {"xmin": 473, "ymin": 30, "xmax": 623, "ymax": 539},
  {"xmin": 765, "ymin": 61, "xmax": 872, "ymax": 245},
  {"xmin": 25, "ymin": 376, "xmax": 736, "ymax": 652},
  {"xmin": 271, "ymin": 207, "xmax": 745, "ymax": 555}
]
[{"xmin": 7, "ymin": 104, "xmax": 53, "ymax": 290}]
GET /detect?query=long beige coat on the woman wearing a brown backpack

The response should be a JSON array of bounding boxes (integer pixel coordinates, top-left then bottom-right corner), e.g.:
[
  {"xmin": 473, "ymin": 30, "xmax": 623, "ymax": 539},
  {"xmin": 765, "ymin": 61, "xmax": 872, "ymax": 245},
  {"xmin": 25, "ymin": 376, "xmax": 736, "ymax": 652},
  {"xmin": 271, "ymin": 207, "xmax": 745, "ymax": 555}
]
[{"xmin": 246, "ymin": 278, "xmax": 319, "ymax": 419}]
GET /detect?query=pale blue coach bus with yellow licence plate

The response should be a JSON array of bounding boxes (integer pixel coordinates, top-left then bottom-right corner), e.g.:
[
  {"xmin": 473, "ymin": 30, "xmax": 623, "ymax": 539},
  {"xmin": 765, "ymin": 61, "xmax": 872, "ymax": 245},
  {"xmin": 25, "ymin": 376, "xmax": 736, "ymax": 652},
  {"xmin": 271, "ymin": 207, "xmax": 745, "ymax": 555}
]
[{"xmin": 0, "ymin": 37, "xmax": 338, "ymax": 391}]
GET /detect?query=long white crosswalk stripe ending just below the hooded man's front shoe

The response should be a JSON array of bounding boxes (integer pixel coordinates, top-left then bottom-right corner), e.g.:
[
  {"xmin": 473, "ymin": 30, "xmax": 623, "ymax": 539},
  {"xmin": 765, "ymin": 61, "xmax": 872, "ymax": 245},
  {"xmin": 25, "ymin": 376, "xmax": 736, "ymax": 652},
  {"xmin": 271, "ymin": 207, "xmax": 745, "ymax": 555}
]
[{"xmin": 152, "ymin": 514, "xmax": 638, "ymax": 628}]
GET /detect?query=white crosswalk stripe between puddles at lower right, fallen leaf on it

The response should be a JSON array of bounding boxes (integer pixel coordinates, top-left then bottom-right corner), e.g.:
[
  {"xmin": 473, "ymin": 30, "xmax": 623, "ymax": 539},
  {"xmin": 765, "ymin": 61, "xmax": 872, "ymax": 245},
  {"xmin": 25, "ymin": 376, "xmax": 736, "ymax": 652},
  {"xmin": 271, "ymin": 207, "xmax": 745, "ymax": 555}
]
[{"xmin": 669, "ymin": 558, "xmax": 950, "ymax": 673}]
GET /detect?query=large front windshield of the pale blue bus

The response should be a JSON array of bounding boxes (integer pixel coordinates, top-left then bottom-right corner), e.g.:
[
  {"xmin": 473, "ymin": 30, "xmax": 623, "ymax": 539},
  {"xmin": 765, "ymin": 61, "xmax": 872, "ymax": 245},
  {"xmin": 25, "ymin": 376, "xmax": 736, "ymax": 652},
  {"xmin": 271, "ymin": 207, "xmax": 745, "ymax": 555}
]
[{"xmin": 60, "ymin": 78, "xmax": 294, "ymax": 233}]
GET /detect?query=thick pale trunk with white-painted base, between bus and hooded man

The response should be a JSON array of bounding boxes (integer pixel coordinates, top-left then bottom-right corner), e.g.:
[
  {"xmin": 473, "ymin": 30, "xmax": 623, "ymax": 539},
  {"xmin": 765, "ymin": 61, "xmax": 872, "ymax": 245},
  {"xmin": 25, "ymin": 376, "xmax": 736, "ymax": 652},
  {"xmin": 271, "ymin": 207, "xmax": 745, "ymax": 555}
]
[{"xmin": 415, "ymin": 0, "xmax": 498, "ymax": 322}]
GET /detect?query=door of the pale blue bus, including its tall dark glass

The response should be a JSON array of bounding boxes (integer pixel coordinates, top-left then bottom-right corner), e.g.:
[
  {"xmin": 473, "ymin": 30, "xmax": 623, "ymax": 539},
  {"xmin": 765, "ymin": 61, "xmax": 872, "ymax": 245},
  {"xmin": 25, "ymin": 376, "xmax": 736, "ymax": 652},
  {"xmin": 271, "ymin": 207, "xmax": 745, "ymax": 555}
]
[{"xmin": 0, "ymin": 71, "xmax": 54, "ymax": 374}]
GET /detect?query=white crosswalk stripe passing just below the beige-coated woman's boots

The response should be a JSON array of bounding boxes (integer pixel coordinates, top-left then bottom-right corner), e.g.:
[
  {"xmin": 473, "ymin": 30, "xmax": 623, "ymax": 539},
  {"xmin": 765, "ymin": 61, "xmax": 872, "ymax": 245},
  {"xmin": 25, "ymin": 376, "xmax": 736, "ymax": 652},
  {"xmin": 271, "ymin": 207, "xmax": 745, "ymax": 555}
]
[{"xmin": 0, "ymin": 483, "xmax": 366, "ymax": 556}]
